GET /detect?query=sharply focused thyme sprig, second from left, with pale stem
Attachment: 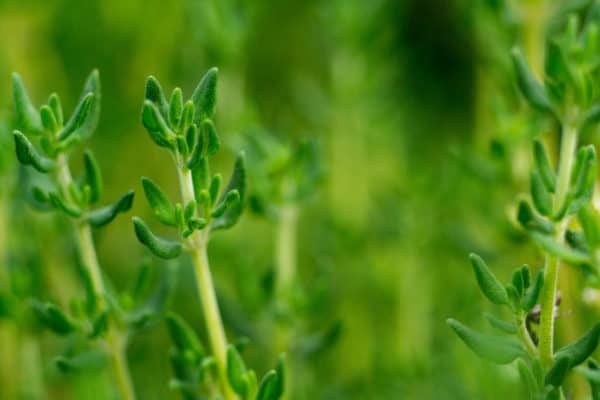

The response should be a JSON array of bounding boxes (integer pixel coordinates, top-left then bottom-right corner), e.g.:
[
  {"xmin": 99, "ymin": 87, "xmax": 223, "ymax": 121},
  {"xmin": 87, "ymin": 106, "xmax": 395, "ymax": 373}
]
[{"xmin": 133, "ymin": 68, "xmax": 284, "ymax": 400}]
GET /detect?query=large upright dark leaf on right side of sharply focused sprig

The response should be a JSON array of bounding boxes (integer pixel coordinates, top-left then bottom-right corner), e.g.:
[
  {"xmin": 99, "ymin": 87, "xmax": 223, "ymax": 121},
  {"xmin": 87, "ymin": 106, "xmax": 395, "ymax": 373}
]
[{"xmin": 212, "ymin": 152, "xmax": 246, "ymax": 230}]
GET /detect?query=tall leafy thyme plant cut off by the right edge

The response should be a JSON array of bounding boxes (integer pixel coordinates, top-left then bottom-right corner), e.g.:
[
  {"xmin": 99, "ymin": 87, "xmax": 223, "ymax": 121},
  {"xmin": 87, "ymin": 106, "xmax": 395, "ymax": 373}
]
[{"xmin": 448, "ymin": 12, "xmax": 600, "ymax": 399}]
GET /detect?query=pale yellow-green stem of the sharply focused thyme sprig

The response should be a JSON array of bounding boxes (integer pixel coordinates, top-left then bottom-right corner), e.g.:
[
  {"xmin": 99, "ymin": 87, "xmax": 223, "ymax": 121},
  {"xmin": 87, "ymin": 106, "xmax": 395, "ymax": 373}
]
[{"xmin": 177, "ymin": 162, "xmax": 237, "ymax": 400}]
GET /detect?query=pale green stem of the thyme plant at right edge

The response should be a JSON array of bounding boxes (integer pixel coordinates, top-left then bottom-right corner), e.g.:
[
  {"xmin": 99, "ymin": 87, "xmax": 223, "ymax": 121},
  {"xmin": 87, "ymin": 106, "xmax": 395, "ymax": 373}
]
[{"xmin": 539, "ymin": 123, "xmax": 577, "ymax": 367}]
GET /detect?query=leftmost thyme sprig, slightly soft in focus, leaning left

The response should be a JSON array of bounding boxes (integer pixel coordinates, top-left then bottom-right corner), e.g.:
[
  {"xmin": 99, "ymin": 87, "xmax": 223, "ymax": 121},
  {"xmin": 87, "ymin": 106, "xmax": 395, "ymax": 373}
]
[{"xmin": 13, "ymin": 71, "xmax": 169, "ymax": 400}]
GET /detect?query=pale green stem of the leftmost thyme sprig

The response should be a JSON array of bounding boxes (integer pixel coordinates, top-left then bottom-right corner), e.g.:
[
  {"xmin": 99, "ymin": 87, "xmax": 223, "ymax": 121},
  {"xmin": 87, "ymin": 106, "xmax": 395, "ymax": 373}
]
[{"xmin": 57, "ymin": 154, "xmax": 135, "ymax": 400}]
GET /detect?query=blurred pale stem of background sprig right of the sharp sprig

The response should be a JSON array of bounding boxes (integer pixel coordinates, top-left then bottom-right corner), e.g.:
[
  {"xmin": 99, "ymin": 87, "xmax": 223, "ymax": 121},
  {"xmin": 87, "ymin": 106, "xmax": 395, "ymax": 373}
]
[{"xmin": 276, "ymin": 204, "xmax": 298, "ymax": 295}]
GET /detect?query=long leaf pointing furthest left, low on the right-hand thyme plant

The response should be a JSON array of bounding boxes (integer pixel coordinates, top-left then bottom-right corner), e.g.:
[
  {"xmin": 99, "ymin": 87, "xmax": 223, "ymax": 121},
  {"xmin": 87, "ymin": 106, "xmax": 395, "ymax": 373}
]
[{"xmin": 446, "ymin": 319, "xmax": 527, "ymax": 364}]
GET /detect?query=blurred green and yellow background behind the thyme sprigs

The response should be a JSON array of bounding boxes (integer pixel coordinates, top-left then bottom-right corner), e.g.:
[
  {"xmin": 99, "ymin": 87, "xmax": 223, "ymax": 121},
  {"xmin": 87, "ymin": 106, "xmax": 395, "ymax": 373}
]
[{"xmin": 0, "ymin": 0, "xmax": 598, "ymax": 400}]
